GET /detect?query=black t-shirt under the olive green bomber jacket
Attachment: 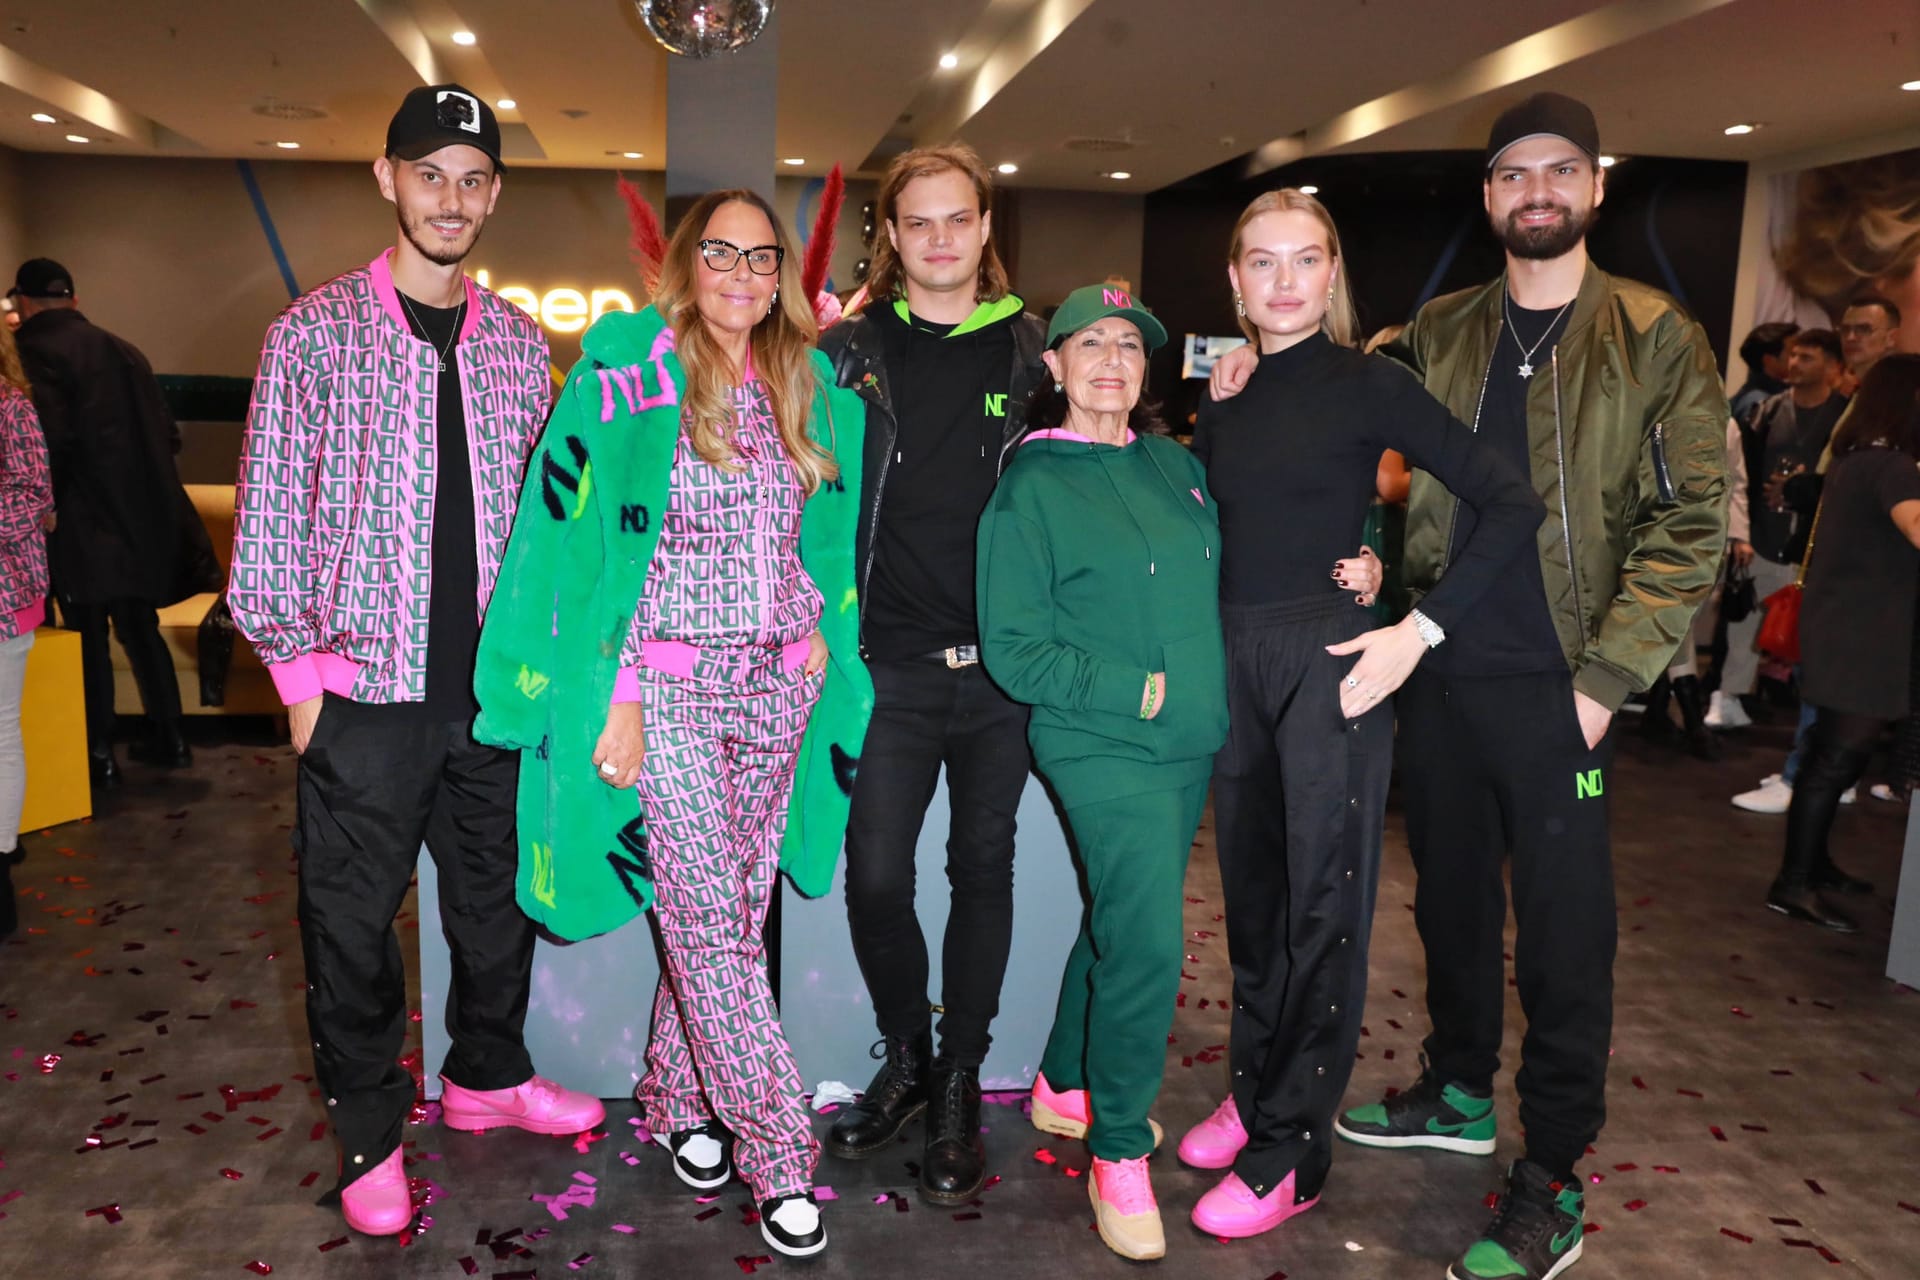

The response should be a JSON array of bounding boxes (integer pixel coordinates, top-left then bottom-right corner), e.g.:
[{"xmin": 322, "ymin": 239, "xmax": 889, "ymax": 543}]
[{"xmin": 1427, "ymin": 297, "xmax": 1572, "ymax": 676}]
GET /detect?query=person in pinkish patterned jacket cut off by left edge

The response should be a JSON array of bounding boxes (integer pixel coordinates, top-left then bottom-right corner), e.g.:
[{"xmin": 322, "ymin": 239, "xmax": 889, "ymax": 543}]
[{"xmin": 0, "ymin": 318, "xmax": 54, "ymax": 940}]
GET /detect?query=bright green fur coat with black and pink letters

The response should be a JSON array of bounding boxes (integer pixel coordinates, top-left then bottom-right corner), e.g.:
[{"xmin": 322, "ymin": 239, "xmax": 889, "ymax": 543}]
[{"xmin": 474, "ymin": 307, "xmax": 874, "ymax": 938}]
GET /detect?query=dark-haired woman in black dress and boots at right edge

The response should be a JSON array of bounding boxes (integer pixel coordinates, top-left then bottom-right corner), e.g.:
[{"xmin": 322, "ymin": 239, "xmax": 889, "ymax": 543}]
[{"xmin": 1766, "ymin": 355, "xmax": 1920, "ymax": 933}]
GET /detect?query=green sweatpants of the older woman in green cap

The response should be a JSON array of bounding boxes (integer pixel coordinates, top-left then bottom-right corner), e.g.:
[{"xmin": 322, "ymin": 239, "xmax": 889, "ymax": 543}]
[{"xmin": 1041, "ymin": 781, "xmax": 1208, "ymax": 1159}]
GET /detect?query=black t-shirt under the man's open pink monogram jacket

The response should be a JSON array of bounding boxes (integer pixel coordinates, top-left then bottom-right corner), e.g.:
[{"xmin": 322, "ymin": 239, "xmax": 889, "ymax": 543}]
[{"xmin": 401, "ymin": 294, "xmax": 480, "ymax": 720}]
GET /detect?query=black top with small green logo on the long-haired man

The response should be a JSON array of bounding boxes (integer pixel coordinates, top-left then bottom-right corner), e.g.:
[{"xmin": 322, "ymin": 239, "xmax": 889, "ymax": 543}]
[{"xmin": 864, "ymin": 305, "xmax": 1018, "ymax": 660}]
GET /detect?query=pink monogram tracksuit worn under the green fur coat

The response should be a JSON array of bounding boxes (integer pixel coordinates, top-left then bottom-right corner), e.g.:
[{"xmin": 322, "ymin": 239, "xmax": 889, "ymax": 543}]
[{"xmin": 614, "ymin": 380, "xmax": 822, "ymax": 1199}]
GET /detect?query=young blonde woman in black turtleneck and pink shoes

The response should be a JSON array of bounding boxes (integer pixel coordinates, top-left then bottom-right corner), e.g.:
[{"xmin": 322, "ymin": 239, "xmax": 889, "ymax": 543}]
[{"xmin": 1181, "ymin": 188, "xmax": 1544, "ymax": 1236}]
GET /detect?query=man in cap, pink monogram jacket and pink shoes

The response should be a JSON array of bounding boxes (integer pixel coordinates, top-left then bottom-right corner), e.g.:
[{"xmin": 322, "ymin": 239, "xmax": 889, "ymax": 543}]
[{"xmin": 228, "ymin": 84, "xmax": 605, "ymax": 1236}]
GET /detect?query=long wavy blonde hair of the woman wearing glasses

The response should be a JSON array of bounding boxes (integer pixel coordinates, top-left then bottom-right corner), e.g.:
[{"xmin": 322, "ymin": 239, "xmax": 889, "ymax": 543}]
[{"xmin": 653, "ymin": 190, "xmax": 839, "ymax": 493}]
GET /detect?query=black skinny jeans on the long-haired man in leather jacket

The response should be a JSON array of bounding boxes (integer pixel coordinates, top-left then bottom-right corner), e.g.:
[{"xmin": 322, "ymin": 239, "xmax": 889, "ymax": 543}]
[{"xmin": 847, "ymin": 660, "xmax": 1033, "ymax": 1067}]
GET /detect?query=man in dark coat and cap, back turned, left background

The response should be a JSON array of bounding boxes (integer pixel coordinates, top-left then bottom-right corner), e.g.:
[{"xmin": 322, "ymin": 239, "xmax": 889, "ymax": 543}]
[{"xmin": 10, "ymin": 257, "xmax": 194, "ymax": 787}]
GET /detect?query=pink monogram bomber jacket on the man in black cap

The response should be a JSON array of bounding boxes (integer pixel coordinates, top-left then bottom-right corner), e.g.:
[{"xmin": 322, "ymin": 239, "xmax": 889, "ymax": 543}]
[{"xmin": 227, "ymin": 249, "xmax": 551, "ymax": 704}]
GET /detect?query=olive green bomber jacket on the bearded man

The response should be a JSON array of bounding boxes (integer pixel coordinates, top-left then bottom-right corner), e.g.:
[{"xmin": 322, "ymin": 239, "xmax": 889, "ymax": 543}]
[{"xmin": 1386, "ymin": 263, "xmax": 1728, "ymax": 710}]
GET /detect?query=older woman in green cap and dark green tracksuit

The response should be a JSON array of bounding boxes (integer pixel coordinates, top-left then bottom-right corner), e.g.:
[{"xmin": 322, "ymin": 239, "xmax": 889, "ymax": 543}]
[{"xmin": 979, "ymin": 286, "xmax": 1227, "ymax": 1259}]
